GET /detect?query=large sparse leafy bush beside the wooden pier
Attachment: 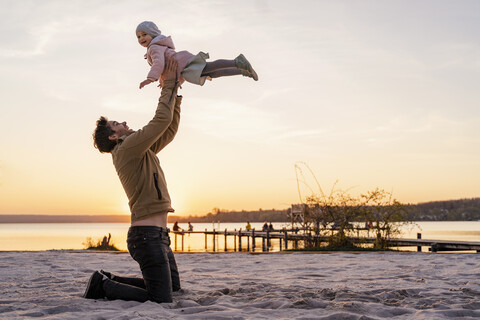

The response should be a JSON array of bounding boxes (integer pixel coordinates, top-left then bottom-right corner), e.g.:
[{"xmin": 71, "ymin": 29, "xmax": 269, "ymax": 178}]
[{"xmin": 289, "ymin": 180, "xmax": 412, "ymax": 250}]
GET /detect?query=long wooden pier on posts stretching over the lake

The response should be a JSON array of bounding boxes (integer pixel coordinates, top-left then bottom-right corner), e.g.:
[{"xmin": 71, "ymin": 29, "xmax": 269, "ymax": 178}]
[{"xmin": 172, "ymin": 229, "xmax": 480, "ymax": 253}]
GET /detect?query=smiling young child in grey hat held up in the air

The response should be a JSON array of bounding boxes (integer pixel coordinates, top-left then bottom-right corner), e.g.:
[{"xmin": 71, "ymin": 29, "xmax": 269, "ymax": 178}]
[{"xmin": 135, "ymin": 21, "xmax": 258, "ymax": 89}]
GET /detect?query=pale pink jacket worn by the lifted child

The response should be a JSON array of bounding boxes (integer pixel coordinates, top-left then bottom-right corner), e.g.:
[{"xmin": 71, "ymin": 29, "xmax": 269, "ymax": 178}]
[{"xmin": 145, "ymin": 35, "xmax": 195, "ymax": 81}]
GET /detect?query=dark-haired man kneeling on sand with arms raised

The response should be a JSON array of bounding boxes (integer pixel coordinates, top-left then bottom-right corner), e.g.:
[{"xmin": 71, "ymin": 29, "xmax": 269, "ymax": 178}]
[{"xmin": 84, "ymin": 62, "xmax": 182, "ymax": 302}]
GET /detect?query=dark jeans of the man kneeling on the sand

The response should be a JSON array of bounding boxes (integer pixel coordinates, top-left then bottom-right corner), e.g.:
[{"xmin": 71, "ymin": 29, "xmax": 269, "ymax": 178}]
[{"xmin": 103, "ymin": 226, "xmax": 180, "ymax": 302}]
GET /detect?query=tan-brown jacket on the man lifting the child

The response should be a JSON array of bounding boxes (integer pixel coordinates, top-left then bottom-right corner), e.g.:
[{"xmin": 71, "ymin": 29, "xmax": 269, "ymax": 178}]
[{"xmin": 112, "ymin": 80, "xmax": 182, "ymax": 222}]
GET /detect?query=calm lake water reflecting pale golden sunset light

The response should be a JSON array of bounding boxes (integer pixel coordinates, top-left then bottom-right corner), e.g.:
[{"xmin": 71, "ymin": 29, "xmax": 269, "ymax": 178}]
[{"xmin": 0, "ymin": 221, "xmax": 480, "ymax": 252}]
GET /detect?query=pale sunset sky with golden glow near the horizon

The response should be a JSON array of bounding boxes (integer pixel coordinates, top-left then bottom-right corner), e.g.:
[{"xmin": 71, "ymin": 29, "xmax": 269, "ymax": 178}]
[{"xmin": 0, "ymin": 0, "xmax": 480, "ymax": 215}]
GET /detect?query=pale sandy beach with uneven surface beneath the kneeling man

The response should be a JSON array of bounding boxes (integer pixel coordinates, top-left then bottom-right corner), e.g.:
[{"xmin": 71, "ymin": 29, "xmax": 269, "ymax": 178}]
[{"xmin": 0, "ymin": 251, "xmax": 480, "ymax": 320}]
